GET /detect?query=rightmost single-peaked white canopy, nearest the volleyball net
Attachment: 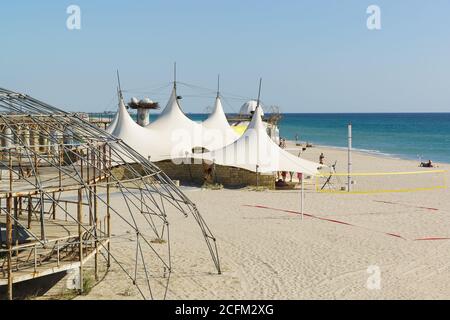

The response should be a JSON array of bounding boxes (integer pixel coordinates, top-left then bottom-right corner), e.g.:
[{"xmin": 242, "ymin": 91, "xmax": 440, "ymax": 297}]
[{"xmin": 191, "ymin": 107, "xmax": 321, "ymax": 175}]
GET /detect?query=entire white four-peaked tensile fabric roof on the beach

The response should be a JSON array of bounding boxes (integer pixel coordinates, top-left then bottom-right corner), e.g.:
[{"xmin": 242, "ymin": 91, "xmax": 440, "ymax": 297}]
[{"xmin": 107, "ymin": 89, "xmax": 308, "ymax": 168}]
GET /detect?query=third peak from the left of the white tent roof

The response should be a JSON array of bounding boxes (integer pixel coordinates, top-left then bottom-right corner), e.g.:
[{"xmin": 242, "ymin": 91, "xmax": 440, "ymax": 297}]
[{"xmin": 202, "ymin": 97, "xmax": 239, "ymax": 151}]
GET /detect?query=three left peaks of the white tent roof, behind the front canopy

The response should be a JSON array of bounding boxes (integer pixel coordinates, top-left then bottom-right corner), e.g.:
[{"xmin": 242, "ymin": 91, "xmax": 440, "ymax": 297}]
[{"xmin": 107, "ymin": 88, "xmax": 241, "ymax": 162}]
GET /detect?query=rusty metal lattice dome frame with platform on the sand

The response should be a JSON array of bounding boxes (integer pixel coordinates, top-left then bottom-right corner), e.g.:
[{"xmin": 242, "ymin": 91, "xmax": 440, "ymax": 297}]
[{"xmin": 0, "ymin": 89, "xmax": 220, "ymax": 299}]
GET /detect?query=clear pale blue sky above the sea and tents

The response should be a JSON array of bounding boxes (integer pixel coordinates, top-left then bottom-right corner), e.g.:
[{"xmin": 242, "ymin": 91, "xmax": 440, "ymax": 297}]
[{"xmin": 0, "ymin": 0, "xmax": 450, "ymax": 112}]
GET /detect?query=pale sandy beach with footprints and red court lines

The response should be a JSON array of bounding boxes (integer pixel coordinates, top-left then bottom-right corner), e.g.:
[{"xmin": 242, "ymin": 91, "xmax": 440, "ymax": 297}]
[{"xmin": 74, "ymin": 144, "xmax": 450, "ymax": 300}]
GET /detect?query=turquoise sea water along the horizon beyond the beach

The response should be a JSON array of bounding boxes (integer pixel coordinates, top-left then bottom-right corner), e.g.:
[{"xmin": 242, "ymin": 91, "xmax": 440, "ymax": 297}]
[{"xmin": 94, "ymin": 113, "xmax": 450, "ymax": 163}]
